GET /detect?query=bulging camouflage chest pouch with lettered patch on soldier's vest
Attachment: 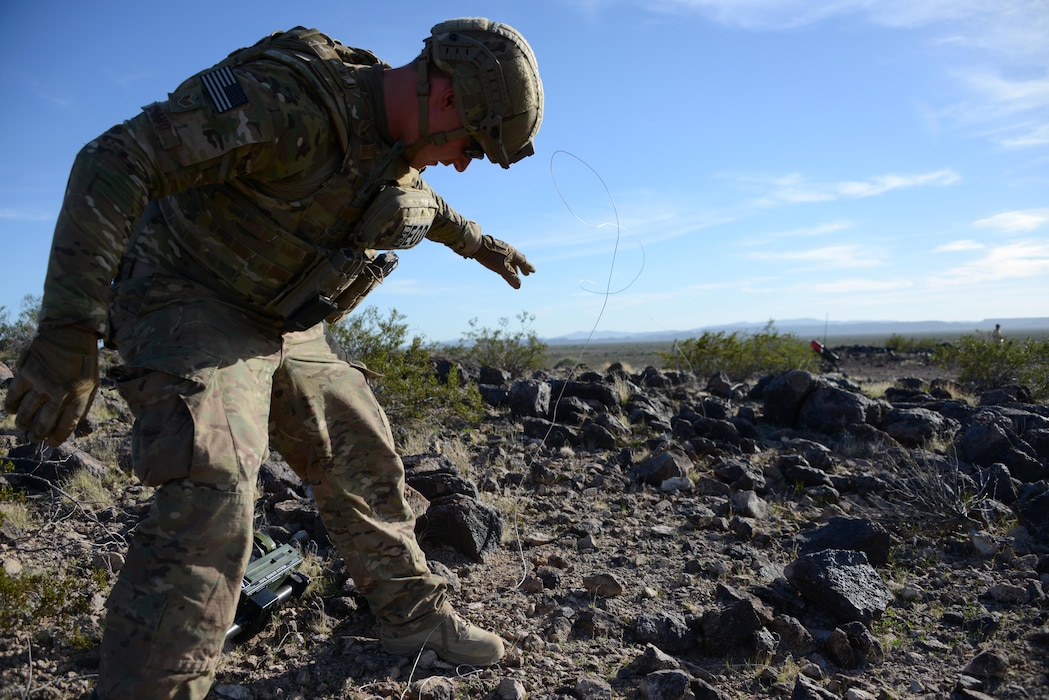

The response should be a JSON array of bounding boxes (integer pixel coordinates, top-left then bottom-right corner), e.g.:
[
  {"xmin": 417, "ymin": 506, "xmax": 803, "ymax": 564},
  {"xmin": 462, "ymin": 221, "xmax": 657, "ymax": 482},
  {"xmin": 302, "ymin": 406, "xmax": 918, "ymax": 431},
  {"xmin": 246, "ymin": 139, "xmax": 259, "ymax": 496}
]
[{"xmin": 350, "ymin": 185, "xmax": 437, "ymax": 250}]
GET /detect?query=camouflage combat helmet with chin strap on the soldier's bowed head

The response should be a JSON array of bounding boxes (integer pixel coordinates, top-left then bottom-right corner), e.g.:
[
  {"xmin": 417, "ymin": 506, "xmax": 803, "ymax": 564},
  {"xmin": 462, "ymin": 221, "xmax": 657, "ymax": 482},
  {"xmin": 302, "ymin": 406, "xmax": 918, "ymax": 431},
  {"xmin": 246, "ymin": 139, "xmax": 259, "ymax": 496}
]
[{"xmin": 416, "ymin": 17, "xmax": 542, "ymax": 168}]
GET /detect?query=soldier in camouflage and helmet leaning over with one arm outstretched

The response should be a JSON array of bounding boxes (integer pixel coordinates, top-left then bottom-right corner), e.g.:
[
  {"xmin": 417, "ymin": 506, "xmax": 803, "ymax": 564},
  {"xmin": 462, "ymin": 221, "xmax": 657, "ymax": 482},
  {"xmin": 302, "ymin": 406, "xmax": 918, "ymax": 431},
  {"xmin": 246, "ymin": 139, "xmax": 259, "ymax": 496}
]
[{"xmin": 6, "ymin": 18, "xmax": 542, "ymax": 699}]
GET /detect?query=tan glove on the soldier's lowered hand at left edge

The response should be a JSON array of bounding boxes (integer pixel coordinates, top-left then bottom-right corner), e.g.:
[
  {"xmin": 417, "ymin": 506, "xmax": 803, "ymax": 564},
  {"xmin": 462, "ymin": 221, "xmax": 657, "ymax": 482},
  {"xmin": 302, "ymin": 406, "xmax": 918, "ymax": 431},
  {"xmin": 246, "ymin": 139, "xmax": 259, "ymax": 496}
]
[{"xmin": 4, "ymin": 325, "xmax": 99, "ymax": 447}]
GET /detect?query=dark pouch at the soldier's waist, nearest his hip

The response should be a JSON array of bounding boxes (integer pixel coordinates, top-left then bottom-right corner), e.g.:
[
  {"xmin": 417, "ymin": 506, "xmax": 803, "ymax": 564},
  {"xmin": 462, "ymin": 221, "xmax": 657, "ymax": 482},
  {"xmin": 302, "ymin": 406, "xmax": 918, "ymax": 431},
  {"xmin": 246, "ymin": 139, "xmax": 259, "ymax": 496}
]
[{"xmin": 266, "ymin": 248, "xmax": 374, "ymax": 333}]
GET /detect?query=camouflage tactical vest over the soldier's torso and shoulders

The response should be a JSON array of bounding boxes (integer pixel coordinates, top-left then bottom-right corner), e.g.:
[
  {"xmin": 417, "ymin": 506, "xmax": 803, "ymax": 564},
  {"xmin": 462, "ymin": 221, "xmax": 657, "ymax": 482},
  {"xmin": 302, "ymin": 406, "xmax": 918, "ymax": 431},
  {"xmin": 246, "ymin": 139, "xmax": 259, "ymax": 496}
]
[{"xmin": 138, "ymin": 27, "xmax": 419, "ymax": 322}]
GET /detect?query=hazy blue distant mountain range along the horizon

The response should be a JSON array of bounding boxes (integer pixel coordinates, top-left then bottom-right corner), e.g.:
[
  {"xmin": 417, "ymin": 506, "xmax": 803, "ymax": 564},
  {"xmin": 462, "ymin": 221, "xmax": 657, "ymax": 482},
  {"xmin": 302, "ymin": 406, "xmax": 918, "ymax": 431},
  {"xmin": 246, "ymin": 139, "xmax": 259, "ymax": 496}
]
[{"xmin": 542, "ymin": 317, "xmax": 1049, "ymax": 344}]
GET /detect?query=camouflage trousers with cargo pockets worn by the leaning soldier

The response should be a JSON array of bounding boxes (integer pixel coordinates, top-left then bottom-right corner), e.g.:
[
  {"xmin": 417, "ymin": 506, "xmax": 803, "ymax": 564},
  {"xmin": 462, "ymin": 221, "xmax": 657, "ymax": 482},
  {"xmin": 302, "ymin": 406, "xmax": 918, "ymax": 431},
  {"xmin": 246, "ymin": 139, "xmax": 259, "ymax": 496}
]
[{"xmin": 98, "ymin": 265, "xmax": 447, "ymax": 699}]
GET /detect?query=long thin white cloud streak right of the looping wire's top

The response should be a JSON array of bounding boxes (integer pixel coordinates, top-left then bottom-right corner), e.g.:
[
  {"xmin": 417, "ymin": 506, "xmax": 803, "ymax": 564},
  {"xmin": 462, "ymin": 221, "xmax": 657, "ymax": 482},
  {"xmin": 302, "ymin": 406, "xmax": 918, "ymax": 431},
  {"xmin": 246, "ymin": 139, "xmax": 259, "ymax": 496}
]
[{"xmin": 742, "ymin": 169, "xmax": 961, "ymax": 207}]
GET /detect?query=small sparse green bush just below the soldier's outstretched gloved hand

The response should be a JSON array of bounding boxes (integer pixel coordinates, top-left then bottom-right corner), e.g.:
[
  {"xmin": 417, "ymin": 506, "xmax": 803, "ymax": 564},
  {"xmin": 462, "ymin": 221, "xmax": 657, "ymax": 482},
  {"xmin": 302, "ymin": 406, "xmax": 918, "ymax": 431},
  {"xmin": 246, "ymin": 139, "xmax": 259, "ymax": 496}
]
[{"xmin": 452, "ymin": 311, "xmax": 547, "ymax": 377}]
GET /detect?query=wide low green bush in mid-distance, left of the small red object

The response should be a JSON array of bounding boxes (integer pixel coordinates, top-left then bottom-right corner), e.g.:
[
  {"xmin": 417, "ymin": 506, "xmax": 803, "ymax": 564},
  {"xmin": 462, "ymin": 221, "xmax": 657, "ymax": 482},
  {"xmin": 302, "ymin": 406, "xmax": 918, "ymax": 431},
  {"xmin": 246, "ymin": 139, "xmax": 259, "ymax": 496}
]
[{"xmin": 660, "ymin": 321, "xmax": 819, "ymax": 382}]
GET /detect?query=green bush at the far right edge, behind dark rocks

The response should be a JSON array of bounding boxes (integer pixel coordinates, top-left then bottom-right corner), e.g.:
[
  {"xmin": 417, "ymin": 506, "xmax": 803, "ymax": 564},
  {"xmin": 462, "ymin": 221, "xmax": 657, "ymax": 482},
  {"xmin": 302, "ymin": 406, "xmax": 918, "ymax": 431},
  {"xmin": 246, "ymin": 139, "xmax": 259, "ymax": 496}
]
[{"xmin": 933, "ymin": 332, "xmax": 1049, "ymax": 400}]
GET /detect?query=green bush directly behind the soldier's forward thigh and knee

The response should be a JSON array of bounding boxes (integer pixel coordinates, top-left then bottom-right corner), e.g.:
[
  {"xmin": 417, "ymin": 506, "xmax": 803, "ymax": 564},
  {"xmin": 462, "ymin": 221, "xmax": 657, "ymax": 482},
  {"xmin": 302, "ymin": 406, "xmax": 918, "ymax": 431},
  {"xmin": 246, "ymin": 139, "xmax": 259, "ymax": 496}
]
[{"xmin": 331, "ymin": 306, "xmax": 483, "ymax": 422}]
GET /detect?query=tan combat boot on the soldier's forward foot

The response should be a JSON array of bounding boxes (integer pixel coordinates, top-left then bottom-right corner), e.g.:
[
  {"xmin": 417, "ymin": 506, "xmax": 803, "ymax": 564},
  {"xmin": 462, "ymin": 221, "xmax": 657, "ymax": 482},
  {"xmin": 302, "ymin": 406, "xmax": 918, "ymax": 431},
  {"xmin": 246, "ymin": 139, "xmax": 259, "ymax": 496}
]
[{"xmin": 382, "ymin": 609, "xmax": 504, "ymax": 666}]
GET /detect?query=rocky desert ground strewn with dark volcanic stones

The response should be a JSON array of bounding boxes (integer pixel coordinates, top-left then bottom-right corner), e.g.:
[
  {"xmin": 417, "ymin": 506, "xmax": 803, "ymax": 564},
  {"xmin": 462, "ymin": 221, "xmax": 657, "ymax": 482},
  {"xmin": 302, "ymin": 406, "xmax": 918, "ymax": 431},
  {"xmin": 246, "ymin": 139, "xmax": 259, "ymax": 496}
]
[{"xmin": 0, "ymin": 348, "xmax": 1049, "ymax": 700}]
